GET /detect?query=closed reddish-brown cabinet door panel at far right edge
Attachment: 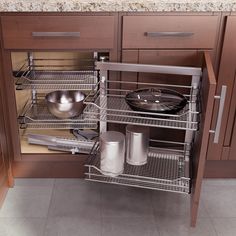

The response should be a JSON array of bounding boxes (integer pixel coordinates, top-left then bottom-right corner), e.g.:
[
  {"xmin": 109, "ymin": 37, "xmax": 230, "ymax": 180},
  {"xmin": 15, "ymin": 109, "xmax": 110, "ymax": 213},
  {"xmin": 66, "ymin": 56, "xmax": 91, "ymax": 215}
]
[{"xmin": 207, "ymin": 16, "xmax": 236, "ymax": 160}]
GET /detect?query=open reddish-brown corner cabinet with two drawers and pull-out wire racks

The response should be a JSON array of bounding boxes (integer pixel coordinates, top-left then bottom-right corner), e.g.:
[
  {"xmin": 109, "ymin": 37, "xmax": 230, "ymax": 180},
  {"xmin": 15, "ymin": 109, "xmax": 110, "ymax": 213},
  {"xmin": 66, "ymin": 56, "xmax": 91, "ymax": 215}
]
[{"xmin": 1, "ymin": 13, "xmax": 226, "ymax": 226}]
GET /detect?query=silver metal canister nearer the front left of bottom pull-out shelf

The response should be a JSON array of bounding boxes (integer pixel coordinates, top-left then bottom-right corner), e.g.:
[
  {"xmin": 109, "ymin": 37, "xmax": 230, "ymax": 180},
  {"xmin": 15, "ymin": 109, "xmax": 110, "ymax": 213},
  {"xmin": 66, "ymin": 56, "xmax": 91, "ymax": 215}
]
[{"xmin": 100, "ymin": 131, "xmax": 125, "ymax": 177}]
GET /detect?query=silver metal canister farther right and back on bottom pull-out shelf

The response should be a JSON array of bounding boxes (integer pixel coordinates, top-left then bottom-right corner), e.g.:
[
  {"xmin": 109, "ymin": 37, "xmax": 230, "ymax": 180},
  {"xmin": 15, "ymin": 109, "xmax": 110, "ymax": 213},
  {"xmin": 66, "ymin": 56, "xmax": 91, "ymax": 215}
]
[{"xmin": 126, "ymin": 125, "xmax": 149, "ymax": 165}]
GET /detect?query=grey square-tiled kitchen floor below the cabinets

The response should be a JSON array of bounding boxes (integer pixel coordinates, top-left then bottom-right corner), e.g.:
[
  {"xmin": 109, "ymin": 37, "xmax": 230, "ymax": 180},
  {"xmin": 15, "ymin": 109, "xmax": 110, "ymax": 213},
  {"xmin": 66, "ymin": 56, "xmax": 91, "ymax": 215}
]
[{"xmin": 0, "ymin": 179, "xmax": 236, "ymax": 236}]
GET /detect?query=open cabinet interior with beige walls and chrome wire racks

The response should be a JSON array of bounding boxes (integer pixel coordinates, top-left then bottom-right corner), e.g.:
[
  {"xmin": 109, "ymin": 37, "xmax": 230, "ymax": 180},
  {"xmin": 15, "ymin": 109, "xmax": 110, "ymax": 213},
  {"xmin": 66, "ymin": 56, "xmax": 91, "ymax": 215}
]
[{"xmin": 12, "ymin": 49, "xmax": 201, "ymax": 194}]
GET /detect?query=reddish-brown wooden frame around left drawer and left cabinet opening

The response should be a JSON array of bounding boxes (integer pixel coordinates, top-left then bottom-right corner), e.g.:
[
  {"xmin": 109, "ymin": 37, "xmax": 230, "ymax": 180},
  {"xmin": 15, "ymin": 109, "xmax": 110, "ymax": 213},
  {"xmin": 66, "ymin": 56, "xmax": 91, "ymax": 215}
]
[{"xmin": 2, "ymin": 13, "xmax": 119, "ymax": 178}]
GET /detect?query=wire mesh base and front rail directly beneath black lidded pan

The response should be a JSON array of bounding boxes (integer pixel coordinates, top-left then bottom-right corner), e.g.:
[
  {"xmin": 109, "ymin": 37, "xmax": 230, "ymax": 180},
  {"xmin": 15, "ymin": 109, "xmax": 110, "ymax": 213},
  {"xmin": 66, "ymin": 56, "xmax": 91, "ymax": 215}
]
[{"xmin": 84, "ymin": 95, "xmax": 198, "ymax": 130}]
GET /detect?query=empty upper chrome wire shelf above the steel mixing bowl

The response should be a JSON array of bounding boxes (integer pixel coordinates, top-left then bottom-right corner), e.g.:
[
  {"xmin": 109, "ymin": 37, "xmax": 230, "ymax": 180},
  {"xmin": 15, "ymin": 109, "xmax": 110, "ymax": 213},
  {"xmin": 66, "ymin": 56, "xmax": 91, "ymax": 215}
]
[{"xmin": 16, "ymin": 70, "xmax": 98, "ymax": 91}]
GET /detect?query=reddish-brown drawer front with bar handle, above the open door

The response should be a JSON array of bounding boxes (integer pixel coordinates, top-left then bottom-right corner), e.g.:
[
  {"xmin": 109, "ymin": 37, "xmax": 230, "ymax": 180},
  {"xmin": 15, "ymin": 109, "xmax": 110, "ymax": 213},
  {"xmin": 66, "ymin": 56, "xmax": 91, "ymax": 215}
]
[{"xmin": 123, "ymin": 16, "xmax": 218, "ymax": 49}]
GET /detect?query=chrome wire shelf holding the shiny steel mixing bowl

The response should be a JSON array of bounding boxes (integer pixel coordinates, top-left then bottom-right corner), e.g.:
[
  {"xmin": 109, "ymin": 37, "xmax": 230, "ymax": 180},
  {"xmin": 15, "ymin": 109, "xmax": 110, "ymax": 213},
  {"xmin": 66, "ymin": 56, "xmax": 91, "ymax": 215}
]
[{"xmin": 18, "ymin": 99, "xmax": 97, "ymax": 129}]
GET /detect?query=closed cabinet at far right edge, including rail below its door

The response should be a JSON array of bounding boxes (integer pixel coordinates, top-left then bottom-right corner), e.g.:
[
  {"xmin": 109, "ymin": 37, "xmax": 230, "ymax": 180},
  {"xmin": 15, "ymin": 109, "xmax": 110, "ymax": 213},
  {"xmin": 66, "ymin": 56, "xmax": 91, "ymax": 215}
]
[{"xmin": 207, "ymin": 15, "xmax": 236, "ymax": 177}]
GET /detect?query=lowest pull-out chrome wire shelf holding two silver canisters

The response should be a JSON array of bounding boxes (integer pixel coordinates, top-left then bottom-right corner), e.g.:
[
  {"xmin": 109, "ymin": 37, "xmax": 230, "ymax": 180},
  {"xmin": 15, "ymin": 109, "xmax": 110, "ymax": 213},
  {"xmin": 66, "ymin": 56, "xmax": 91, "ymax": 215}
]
[{"xmin": 85, "ymin": 142, "xmax": 190, "ymax": 194}]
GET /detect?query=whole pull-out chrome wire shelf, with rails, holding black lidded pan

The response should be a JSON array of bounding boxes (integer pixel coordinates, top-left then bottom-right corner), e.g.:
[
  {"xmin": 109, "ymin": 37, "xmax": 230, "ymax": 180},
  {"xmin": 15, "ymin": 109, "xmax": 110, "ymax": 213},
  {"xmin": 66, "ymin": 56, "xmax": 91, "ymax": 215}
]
[{"xmin": 84, "ymin": 82, "xmax": 199, "ymax": 131}]
